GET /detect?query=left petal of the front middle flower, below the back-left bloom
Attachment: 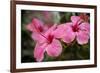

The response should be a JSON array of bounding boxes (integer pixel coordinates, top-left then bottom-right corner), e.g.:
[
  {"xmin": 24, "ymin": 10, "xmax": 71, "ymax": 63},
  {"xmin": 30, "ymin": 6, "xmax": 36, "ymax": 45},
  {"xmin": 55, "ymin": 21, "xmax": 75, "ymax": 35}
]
[{"xmin": 32, "ymin": 32, "xmax": 47, "ymax": 43}]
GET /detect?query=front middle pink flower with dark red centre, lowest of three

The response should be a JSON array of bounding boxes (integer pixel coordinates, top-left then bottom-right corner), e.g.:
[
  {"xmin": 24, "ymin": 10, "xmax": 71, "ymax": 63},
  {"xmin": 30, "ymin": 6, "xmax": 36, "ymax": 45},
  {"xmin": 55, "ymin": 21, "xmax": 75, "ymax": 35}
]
[{"xmin": 32, "ymin": 25, "xmax": 62, "ymax": 61}]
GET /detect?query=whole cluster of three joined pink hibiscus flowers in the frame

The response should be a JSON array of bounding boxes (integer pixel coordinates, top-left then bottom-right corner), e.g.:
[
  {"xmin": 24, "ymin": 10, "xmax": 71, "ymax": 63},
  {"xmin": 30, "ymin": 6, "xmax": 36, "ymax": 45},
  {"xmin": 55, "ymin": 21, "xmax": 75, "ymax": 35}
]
[{"xmin": 26, "ymin": 16, "xmax": 90, "ymax": 61}]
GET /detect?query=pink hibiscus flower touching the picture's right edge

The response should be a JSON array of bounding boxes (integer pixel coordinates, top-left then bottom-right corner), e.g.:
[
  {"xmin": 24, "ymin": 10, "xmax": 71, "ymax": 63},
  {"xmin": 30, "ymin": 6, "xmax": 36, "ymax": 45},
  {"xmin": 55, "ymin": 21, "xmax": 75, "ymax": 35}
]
[{"xmin": 55, "ymin": 16, "xmax": 90, "ymax": 45}]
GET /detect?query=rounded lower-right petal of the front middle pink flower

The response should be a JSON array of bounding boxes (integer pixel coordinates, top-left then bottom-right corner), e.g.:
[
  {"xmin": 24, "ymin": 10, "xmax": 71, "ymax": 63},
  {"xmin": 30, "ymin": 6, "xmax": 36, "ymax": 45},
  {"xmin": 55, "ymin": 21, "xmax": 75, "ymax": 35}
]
[{"xmin": 46, "ymin": 39, "xmax": 62, "ymax": 57}]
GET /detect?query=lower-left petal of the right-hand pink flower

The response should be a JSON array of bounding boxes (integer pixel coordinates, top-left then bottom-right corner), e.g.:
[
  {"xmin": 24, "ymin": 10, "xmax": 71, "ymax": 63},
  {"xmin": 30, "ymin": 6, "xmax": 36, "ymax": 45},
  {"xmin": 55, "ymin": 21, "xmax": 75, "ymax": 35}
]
[{"xmin": 62, "ymin": 26, "xmax": 75, "ymax": 43}]
